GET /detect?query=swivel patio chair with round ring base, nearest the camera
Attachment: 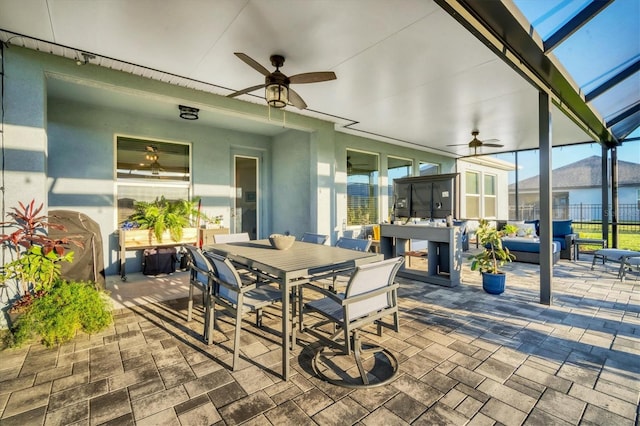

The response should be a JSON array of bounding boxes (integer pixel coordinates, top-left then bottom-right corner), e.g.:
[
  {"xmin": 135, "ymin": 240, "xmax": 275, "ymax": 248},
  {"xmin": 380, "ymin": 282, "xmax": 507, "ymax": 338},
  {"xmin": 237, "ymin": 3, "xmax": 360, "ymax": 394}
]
[{"xmin": 301, "ymin": 257, "xmax": 404, "ymax": 388}]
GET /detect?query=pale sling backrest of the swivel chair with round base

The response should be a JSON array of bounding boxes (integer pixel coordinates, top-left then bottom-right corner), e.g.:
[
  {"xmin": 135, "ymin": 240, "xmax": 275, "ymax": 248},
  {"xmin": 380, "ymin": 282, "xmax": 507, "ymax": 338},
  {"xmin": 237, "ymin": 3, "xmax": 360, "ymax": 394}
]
[{"xmin": 345, "ymin": 257, "xmax": 404, "ymax": 321}]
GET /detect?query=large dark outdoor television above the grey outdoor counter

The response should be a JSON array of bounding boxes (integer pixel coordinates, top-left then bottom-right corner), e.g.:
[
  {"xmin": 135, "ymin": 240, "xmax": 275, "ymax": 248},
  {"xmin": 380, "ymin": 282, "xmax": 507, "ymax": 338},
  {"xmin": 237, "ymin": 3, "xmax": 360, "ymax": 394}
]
[{"xmin": 393, "ymin": 173, "xmax": 460, "ymax": 219}]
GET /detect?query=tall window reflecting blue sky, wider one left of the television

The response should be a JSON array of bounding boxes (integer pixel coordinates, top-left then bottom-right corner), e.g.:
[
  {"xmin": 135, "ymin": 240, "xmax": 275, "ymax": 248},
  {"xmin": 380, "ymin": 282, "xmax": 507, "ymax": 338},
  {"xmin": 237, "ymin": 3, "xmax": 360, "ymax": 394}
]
[{"xmin": 347, "ymin": 150, "xmax": 379, "ymax": 225}]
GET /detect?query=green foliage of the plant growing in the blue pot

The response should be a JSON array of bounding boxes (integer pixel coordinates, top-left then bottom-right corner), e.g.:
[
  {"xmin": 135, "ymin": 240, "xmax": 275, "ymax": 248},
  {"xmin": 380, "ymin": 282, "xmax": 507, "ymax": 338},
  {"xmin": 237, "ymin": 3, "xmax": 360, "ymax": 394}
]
[{"xmin": 469, "ymin": 219, "xmax": 516, "ymax": 274}]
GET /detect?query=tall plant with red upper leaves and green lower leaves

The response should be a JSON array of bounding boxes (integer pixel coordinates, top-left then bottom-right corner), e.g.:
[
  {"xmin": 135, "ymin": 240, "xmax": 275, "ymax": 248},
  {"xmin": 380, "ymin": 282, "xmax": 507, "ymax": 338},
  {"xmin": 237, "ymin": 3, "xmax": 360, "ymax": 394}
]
[{"xmin": 0, "ymin": 200, "xmax": 82, "ymax": 297}]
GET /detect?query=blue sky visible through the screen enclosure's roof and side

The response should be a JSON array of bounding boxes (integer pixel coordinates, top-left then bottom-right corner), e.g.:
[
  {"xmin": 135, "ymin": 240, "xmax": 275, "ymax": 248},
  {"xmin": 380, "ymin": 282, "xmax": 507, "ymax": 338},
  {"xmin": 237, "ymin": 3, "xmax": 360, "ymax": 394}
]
[{"xmin": 497, "ymin": 0, "xmax": 640, "ymax": 183}]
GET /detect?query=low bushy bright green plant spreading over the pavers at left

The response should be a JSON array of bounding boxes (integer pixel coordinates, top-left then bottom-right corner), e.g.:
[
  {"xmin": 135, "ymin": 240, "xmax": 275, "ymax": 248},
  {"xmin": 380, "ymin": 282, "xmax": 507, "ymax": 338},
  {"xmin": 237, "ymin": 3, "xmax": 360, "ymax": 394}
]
[{"xmin": 12, "ymin": 280, "xmax": 113, "ymax": 346}]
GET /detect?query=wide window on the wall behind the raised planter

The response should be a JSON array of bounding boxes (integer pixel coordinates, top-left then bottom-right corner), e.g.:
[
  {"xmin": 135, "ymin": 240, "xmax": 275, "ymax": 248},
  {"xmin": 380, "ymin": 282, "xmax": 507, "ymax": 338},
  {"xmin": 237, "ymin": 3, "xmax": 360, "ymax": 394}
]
[{"xmin": 116, "ymin": 136, "xmax": 191, "ymax": 224}]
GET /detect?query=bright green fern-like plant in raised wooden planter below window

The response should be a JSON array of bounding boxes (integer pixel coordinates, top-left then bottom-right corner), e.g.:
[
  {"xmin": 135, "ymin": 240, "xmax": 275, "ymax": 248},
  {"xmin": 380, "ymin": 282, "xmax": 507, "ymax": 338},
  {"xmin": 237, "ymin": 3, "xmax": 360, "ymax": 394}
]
[{"xmin": 129, "ymin": 197, "xmax": 207, "ymax": 242}]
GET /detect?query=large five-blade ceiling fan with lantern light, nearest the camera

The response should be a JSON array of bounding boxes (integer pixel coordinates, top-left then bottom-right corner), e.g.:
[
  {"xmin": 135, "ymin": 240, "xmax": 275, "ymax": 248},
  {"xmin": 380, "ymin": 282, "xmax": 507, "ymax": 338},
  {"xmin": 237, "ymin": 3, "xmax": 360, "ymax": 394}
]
[{"xmin": 227, "ymin": 52, "xmax": 336, "ymax": 109}]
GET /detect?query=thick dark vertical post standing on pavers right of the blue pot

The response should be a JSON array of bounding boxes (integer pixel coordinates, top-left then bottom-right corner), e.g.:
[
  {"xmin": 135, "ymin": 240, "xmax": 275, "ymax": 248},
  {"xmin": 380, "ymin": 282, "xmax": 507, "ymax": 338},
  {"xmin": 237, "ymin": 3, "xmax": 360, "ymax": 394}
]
[{"xmin": 538, "ymin": 91, "xmax": 553, "ymax": 305}]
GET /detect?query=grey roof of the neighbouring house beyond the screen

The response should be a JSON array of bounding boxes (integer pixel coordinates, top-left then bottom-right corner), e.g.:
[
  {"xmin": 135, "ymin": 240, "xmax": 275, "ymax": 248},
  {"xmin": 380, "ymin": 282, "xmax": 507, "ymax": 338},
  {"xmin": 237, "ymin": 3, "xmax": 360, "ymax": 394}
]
[{"xmin": 509, "ymin": 155, "xmax": 640, "ymax": 192}]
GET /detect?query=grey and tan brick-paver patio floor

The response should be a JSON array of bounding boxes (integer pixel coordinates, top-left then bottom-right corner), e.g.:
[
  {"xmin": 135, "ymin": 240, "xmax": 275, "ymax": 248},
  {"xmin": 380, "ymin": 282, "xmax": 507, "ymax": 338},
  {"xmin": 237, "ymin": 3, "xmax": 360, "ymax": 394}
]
[{"xmin": 0, "ymin": 255, "xmax": 640, "ymax": 425}]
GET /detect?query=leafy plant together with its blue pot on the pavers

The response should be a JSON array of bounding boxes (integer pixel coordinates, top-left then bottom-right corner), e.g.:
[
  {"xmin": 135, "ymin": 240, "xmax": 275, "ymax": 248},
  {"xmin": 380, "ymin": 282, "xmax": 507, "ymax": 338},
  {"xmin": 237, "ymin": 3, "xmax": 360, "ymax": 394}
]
[{"xmin": 469, "ymin": 219, "xmax": 515, "ymax": 294}]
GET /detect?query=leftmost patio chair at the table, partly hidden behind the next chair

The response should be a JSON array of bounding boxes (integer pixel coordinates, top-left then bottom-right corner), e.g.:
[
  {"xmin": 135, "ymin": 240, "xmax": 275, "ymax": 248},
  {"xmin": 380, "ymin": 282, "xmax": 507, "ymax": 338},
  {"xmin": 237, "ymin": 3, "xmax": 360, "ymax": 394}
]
[{"xmin": 184, "ymin": 245, "xmax": 214, "ymax": 344}]
